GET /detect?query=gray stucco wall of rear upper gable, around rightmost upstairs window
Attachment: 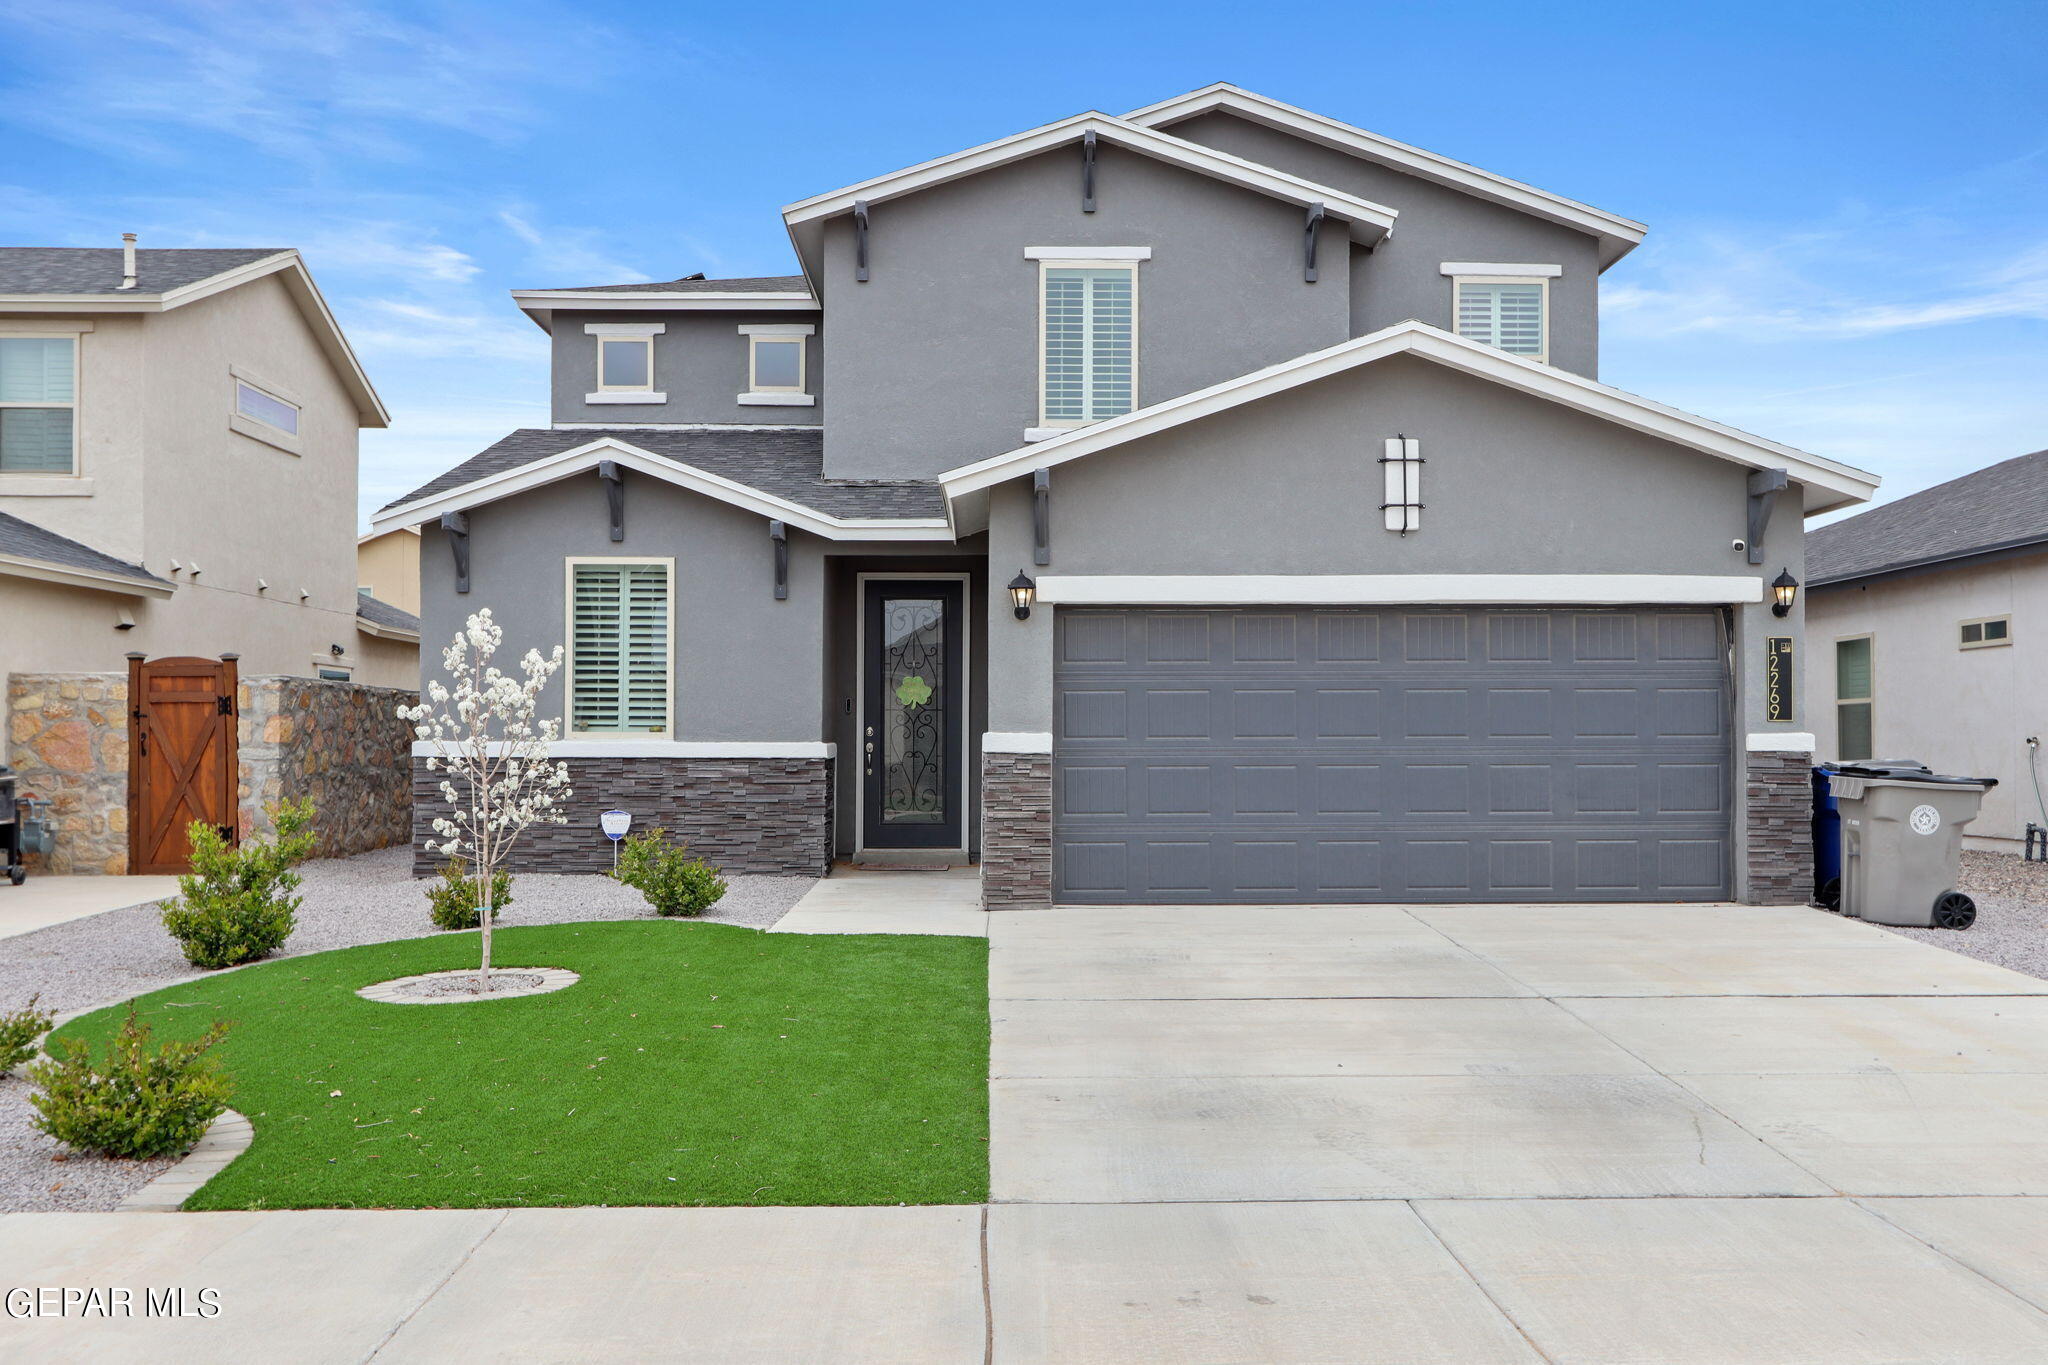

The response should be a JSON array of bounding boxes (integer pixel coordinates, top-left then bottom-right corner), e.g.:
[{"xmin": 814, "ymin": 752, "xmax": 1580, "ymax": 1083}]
[{"xmin": 1165, "ymin": 113, "xmax": 1599, "ymax": 379}]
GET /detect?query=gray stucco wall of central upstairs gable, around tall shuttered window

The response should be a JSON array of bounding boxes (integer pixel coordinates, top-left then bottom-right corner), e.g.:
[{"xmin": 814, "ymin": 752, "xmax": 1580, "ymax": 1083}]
[{"xmin": 821, "ymin": 145, "xmax": 1350, "ymax": 479}]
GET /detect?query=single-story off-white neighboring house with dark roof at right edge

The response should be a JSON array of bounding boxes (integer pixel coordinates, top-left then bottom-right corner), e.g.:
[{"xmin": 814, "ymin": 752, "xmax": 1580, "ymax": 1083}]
[{"xmin": 1806, "ymin": 450, "xmax": 2048, "ymax": 851}]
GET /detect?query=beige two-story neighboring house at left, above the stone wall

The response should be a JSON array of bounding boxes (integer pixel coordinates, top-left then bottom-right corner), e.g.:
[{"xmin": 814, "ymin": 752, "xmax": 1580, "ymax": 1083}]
[{"xmin": 0, "ymin": 246, "xmax": 418, "ymax": 686}]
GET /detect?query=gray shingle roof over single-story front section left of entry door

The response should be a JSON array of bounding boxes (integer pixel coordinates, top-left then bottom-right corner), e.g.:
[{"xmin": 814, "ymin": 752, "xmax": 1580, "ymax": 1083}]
[{"xmin": 383, "ymin": 428, "xmax": 946, "ymax": 518}]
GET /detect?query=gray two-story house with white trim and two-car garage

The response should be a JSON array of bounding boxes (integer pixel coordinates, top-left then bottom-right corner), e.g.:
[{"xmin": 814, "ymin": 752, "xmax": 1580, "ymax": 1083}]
[{"xmin": 377, "ymin": 84, "xmax": 1876, "ymax": 909}]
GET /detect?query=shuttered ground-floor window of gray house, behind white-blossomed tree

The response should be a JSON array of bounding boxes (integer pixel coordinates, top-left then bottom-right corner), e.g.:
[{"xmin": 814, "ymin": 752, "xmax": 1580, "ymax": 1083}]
[{"xmin": 565, "ymin": 559, "xmax": 676, "ymax": 739}]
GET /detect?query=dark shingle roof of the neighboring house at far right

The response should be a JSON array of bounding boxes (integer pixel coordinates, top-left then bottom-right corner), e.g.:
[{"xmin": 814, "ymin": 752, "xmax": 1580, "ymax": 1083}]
[{"xmin": 1806, "ymin": 450, "xmax": 2048, "ymax": 585}]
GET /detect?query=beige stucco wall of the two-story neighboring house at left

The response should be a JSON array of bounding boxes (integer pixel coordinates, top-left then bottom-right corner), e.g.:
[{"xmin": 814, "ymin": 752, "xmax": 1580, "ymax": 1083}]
[{"xmin": 0, "ymin": 278, "xmax": 414, "ymax": 686}]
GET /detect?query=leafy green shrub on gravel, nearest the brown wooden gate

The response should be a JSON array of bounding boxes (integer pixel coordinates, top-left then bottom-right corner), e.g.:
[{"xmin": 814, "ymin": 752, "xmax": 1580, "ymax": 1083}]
[{"xmin": 164, "ymin": 800, "xmax": 313, "ymax": 972}]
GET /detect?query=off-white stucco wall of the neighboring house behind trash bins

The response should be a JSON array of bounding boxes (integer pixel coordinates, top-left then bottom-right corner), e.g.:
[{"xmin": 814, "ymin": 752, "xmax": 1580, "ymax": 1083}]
[{"xmin": 1802, "ymin": 555, "xmax": 2048, "ymax": 851}]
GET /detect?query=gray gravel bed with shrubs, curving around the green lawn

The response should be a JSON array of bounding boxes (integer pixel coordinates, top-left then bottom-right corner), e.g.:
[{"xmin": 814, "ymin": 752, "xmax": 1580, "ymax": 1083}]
[{"xmin": 0, "ymin": 847, "xmax": 815, "ymax": 1214}]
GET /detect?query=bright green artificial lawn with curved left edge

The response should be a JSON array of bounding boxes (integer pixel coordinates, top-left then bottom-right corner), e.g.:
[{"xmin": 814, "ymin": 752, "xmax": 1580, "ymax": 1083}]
[{"xmin": 59, "ymin": 921, "xmax": 989, "ymax": 1209}]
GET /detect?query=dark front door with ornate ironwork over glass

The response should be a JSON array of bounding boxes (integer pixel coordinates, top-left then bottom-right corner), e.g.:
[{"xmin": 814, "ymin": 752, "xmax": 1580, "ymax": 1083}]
[{"xmin": 860, "ymin": 579, "xmax": 967, "ymax": 849}]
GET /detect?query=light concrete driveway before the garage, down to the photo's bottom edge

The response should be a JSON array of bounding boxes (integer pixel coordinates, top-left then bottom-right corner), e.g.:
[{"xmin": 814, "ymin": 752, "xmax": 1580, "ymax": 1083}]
[{"xmin": 989, "ymin": 907, "xmax": 2048, "ymax": 1363}]
